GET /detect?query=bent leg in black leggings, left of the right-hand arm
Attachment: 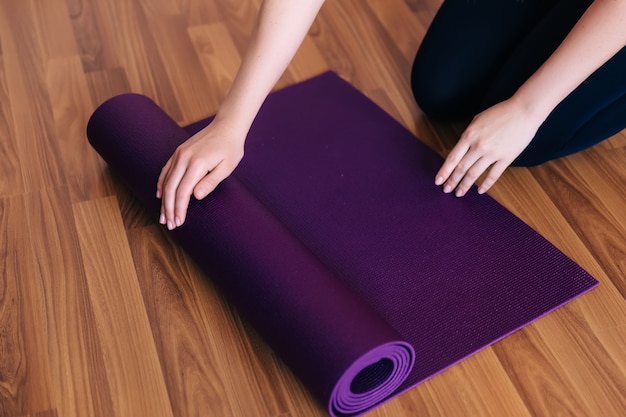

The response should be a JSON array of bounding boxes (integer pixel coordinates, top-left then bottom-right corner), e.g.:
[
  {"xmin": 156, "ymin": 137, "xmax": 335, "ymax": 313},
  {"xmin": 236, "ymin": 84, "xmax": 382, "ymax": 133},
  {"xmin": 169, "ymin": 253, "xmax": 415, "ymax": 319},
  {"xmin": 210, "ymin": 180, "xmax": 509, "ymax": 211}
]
[{"xmin": 411, "ymin": 0, "xmax": 553, "ymax": 119}]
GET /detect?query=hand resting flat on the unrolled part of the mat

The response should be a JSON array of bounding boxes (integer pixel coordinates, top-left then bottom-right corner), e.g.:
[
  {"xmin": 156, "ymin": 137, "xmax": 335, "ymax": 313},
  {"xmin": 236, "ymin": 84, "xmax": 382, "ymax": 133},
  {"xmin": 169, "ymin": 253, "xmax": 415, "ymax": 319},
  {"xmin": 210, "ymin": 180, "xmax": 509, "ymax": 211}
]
[{"xmin": 435, "ymin": 100, "xmax": 541, "ymax": 197}]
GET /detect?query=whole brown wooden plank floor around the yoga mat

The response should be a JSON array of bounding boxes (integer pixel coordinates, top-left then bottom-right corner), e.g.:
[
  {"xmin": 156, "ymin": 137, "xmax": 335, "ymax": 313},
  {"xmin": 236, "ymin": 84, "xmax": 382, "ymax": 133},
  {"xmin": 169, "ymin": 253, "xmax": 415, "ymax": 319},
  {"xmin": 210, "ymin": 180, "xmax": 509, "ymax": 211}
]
[{"xmin": 0, "ymin": 0, "xmax": 626, "ymax": 417}]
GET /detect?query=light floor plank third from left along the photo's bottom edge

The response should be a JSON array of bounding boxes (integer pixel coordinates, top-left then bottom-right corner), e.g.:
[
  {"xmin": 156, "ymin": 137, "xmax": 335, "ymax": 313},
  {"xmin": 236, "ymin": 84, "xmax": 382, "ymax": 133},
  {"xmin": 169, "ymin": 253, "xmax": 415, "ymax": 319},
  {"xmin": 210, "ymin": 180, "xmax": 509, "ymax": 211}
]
[{"xmin": 73, "ymin": 197, "xmax": 173, "ymax": 417}]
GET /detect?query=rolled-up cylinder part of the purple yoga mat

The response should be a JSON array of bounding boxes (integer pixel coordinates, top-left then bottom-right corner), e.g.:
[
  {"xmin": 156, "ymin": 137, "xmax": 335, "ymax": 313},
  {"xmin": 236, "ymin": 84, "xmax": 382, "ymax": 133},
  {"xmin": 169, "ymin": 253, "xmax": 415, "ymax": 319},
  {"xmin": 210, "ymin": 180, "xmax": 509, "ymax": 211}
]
[{"xmin": 87, "ymin": 94, "xmax": 415, "ymax": 417}]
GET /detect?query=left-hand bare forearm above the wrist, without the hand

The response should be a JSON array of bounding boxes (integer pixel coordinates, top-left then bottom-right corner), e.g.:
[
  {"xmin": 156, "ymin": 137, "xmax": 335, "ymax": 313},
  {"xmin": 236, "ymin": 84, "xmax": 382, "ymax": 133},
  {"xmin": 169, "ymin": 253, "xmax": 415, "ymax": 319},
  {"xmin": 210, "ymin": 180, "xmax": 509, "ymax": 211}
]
[{"xmin": 216, "ymin": 0, "xmax": 324, "ymax": 137}]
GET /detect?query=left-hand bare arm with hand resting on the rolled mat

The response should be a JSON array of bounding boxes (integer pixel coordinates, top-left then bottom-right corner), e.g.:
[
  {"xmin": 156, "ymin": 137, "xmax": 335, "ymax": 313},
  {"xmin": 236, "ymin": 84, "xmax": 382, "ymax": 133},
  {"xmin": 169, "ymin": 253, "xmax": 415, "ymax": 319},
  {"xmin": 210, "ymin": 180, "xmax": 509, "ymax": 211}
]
[{"xmin": 157, "ymin": 0, "xmax": 324, "ymax": 230}]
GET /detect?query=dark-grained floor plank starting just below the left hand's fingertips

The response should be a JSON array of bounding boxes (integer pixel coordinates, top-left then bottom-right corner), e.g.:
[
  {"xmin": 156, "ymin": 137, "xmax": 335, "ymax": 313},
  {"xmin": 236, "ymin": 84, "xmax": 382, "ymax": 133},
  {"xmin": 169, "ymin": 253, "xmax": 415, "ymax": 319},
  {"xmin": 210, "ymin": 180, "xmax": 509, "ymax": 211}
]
[{"xmin": 128, "ymin": 226, "xmax": 234, "ymax": 416}]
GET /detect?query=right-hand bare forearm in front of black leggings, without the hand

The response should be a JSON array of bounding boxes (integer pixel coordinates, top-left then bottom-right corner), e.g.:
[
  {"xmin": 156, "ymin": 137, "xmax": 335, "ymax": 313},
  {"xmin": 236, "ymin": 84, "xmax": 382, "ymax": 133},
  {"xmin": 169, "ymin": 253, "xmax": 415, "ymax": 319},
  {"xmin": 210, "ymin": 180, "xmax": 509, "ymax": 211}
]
[{"xmin": 512, "ymin": 0, "xmax": 626, "ymax": 123}]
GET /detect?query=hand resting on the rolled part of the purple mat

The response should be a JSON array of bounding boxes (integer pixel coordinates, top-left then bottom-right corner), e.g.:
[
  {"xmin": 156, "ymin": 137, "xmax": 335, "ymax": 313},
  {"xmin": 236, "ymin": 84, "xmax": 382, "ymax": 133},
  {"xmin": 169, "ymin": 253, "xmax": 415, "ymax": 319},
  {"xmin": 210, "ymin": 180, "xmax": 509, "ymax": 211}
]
[{"xmin": 157, "ymin": 121, "xmax": 246, "ymax": 230}]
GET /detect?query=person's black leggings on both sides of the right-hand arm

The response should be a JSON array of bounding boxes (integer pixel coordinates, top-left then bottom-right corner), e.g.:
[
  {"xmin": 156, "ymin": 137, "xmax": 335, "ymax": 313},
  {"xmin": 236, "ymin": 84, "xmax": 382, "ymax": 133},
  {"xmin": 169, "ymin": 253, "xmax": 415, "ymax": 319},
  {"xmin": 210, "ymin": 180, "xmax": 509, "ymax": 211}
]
[{"xmin": 411, "ymin": 0, "xmax": 626, "ymax": 166}]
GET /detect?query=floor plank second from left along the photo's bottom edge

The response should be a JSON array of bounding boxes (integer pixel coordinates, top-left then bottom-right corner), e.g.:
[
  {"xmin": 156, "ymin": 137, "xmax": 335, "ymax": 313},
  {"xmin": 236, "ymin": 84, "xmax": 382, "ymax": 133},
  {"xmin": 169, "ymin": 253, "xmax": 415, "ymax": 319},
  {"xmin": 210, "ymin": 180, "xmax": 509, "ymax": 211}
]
[{"xmin": 21, "ymin": 187, "xmax": 114, "ymax": 417}]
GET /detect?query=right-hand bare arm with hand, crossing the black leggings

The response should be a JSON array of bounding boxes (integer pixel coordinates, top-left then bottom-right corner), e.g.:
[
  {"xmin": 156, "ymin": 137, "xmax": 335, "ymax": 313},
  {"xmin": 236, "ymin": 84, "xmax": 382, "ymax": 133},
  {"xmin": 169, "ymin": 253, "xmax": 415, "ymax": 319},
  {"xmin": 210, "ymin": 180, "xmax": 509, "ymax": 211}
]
[{"xmin": 435, "ymin": 0, "xmax": 626, "ymax": 197}]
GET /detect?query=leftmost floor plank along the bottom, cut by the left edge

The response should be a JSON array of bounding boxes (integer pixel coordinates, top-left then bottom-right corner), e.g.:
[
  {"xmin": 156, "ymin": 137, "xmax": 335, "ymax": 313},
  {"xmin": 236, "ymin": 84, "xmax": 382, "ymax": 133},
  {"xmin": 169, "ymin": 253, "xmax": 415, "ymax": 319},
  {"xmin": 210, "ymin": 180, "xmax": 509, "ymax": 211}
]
[{"xmin": 0, "ymin": 195, "xmax": 54, "ymax": 416}]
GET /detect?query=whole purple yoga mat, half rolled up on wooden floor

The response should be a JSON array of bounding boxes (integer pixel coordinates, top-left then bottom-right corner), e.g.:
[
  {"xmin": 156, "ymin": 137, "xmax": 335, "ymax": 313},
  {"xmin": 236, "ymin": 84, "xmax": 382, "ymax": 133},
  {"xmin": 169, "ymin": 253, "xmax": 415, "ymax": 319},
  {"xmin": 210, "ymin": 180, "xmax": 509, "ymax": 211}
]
[{"xmin": 87, "ymin": 72, "xmax": 597, "ymax": 417}]
